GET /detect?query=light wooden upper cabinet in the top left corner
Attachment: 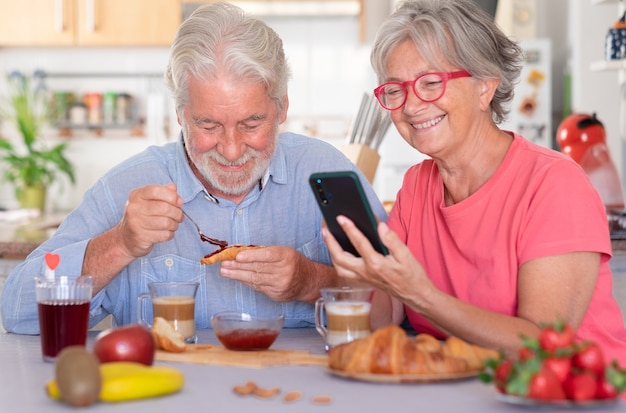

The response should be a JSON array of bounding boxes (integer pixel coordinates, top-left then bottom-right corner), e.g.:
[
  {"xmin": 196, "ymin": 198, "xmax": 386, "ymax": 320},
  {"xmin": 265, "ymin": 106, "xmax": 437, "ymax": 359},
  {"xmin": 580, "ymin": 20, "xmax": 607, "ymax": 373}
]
[{"xmin": 0, "ymin": 0, "xmax": 182, "ymax": 47}]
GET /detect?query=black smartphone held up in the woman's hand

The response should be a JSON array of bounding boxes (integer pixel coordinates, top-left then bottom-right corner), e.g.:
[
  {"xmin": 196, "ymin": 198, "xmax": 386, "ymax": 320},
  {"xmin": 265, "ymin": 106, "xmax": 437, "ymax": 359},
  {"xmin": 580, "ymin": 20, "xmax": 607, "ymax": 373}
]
[{"xmin": 309, "ymin": 171, "xmax": 388, "ymax": 257}]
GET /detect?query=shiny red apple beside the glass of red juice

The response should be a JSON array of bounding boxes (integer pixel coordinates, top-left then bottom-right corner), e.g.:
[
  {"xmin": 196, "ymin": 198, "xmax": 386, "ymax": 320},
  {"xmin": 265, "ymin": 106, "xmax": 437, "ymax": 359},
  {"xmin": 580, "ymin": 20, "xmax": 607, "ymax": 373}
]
[{"xmin": 93, "ymin": 324, "xmax": 155, "ymax": 366}]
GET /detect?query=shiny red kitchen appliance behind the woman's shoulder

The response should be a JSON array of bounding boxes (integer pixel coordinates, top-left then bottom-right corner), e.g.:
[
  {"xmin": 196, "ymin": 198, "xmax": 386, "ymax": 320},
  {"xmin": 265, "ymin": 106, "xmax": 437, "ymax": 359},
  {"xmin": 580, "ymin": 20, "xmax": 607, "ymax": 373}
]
[{"xmin": 556, "ymin": 113, "xmax": 624, "ymax": 211}]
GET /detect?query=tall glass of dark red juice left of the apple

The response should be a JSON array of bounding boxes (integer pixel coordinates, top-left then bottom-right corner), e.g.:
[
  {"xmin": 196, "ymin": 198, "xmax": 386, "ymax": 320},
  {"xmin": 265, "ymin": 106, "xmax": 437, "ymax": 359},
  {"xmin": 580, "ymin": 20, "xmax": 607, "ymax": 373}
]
[{"xmin": 35, "ymin": 276, "xmax": 93, "ymax": 362}]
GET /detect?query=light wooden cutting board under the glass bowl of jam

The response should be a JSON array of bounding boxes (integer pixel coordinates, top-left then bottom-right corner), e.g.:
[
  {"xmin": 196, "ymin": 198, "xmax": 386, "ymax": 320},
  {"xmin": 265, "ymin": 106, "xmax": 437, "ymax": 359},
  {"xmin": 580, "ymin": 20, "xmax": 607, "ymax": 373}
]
[{"xmin": 155, "ymin": 344, "xmax": 328, "ymax": 368}]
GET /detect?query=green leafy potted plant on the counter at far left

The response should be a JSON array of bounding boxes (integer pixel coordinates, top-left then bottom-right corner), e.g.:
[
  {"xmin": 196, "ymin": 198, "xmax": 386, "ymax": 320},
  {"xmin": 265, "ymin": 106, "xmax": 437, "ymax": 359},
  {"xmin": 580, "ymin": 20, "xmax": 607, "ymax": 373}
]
[{"xmin": 0, "ymin": 72, "xmax": 75, "ymax": 211}]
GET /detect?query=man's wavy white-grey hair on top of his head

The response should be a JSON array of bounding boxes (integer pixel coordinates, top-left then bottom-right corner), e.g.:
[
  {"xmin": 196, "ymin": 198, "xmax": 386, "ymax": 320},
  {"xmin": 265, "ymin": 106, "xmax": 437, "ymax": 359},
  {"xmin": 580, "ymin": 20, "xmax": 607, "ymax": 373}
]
[{"xmin": 165, "ymin": 2, "xmax": 291, "ymax": 112}]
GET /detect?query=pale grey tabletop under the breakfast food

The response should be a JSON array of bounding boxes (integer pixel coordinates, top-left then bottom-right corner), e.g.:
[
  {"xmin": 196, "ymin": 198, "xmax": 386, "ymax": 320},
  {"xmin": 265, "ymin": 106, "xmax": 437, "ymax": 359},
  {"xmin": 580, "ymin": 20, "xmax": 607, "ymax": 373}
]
[{"xmin": 0, "ymin": 329, "xmax": 625, "ymax": 413}]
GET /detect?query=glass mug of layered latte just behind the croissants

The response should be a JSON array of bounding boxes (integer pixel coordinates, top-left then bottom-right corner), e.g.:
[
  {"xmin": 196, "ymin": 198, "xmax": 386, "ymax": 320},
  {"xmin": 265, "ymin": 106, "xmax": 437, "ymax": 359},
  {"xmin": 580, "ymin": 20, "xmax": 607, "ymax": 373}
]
[{"xmin": 315, "ymin": 287, "xmax": 374, "ymax": 351}]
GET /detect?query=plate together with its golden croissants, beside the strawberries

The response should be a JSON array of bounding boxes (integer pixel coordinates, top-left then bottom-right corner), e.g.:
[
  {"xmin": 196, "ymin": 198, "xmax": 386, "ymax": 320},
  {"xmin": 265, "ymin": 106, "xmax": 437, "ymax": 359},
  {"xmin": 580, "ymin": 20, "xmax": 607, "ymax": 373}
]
[{"xmin": 328, "ymin": 326, "xmax": 499, "ymax": 383}]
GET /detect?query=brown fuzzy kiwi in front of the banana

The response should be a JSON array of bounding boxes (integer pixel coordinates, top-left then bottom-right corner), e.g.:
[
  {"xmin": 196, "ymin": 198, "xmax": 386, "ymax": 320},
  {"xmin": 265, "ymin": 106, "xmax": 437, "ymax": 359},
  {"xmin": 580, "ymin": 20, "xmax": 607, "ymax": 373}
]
[{"xmin": 54, "ymin": 346, "xmax": 102, "ymax": 407}]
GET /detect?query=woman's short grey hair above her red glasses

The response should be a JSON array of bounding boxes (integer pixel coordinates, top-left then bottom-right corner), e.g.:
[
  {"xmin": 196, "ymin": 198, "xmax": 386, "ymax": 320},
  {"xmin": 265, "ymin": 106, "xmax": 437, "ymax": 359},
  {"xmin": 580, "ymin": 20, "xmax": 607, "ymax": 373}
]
[{"xmin": 370, "ymin": 0, "xmax": 524, "ymax": 123}]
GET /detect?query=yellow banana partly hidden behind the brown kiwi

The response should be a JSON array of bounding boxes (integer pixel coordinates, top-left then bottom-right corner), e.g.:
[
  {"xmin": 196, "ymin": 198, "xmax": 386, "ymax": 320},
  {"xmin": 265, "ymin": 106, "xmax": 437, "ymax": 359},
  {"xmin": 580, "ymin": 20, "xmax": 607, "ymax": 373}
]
[{"xmin": 46, "ymin": 361, "xmax": 185, "ymax": 403}]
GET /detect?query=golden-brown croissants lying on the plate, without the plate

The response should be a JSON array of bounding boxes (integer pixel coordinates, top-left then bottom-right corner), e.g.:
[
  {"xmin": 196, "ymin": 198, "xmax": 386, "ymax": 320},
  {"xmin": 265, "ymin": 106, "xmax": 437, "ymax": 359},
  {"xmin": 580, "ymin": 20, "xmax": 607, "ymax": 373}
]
[{"xmin": 328, "ymin": 326, "xmax": 497, "ymax": 374}]
